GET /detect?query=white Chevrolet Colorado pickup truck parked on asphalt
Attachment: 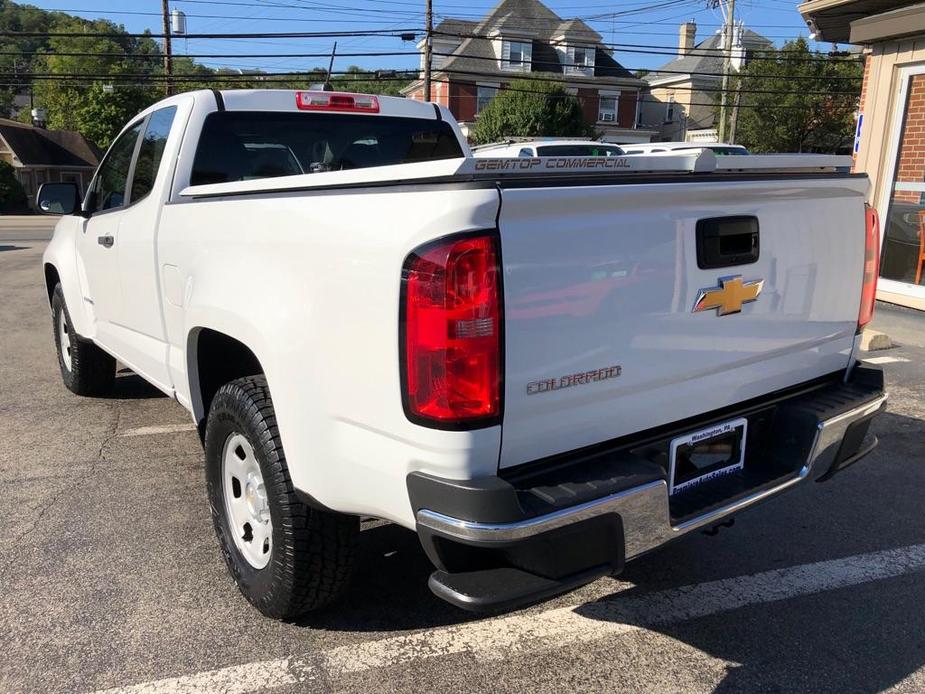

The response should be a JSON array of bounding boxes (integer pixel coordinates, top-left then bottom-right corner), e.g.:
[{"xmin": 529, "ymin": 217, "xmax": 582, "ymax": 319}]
[{"xmin": 37, "ymin": 91, "xmax": 886, "ymax": 619}]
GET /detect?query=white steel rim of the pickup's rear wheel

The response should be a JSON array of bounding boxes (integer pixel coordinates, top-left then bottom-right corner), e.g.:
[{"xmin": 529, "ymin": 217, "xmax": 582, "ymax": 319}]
[{"xmin": 222, "ymin": 432, "xmax": 273, "ymax": 569}]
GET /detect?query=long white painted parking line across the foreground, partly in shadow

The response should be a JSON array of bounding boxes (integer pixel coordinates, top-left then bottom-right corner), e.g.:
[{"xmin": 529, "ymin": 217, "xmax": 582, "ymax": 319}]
[{"xmin": 90, "ymin": 544, "xmax": 925, "ymax": 694}]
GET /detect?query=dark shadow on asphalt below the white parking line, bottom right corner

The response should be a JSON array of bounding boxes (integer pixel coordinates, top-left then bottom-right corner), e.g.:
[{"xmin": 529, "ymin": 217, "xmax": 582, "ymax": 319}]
[{"xmin": 576, "ymin": 575, "xmax": 925, "ymax": 694}]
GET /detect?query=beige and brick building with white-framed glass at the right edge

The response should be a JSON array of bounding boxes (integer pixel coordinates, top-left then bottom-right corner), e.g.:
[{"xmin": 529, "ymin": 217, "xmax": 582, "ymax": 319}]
[{"xmin": 799, "ymin": 0, "xmax": 925, "ymax": 310}]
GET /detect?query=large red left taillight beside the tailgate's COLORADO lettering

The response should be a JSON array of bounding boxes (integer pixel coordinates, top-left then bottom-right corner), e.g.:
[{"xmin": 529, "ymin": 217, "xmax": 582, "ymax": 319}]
[{"xmin": 401, "ymin": 235, "xmax": 501, "ymax": 427}]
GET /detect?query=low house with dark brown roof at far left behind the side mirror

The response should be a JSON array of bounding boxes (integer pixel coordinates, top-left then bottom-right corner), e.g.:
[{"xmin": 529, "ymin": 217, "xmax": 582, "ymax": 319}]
[{"xmin": 0, "ymin": 118, "xmax": 100, "ymax": 206}]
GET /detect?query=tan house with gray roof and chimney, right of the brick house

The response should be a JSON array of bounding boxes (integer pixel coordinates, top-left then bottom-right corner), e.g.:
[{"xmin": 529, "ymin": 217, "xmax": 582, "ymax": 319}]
[{"xmin": 639, "ymin": 21, "xmax": 773, "ymax": 142}]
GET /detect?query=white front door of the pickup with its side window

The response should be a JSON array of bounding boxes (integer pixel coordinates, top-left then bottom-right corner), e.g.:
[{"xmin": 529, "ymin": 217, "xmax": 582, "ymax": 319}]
[{"xmin": 77, "ymin": 120, "xmax": 144, "ymax": 351}]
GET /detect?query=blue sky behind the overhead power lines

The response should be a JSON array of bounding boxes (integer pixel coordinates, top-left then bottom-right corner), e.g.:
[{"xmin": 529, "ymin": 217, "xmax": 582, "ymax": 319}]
[{"xmin": 30, "ymin": 0, "xmax": 827, "ymax": 72}]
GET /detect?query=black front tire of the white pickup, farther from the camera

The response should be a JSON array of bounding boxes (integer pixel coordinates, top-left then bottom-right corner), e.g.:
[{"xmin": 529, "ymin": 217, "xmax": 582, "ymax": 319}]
[{"xmin": 51, "ymin": 284, "xmax": 116, "ymax": 395}]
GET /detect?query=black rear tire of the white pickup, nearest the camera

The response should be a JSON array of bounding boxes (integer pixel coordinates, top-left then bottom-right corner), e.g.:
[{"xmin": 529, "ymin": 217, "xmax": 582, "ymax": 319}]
[{"xmin": 205, "ymin": 376, "xmax": 360, "ymax": 621}]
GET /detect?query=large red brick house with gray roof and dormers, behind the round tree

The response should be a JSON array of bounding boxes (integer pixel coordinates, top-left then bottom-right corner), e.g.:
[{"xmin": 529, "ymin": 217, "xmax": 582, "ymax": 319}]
[{"xmin": 402, "ymin": 0, "xmax": 652, "ymax": 143}]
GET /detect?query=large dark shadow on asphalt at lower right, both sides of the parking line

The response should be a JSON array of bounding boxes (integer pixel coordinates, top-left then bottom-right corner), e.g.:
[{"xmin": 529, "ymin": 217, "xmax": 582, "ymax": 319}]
[{"xmin": 576, "ymin": 412, "xmax": 925, "ymax": 694}]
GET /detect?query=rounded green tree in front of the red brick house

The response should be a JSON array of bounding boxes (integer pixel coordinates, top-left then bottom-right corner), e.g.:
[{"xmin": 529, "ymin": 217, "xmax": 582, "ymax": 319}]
[{"xmin": 471, "ymin": 80, "xmax": 594, "ymax": 144}]
